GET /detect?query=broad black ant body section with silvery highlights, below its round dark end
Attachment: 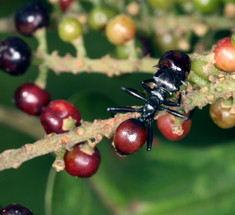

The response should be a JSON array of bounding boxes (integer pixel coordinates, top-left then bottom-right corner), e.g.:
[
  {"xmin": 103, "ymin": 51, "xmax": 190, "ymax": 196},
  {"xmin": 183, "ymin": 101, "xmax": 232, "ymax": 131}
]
[{"xmin": 153, "ymin": 66, "xmax": 186, "ymax": 94}]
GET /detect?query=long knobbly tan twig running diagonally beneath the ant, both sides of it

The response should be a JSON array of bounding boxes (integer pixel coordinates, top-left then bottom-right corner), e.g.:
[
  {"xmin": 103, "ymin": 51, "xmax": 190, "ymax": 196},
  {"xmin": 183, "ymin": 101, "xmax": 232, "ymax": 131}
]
[{"xmin": 0, "ymin": 64, "xmax": 235, "ymax": 170}]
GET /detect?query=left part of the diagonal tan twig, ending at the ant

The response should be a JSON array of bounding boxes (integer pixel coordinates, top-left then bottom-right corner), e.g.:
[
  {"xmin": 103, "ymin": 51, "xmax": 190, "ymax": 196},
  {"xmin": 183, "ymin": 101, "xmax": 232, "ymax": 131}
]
[{"xmin": 0, "ymin": 113, "xmax": 140, "ymax": 170}]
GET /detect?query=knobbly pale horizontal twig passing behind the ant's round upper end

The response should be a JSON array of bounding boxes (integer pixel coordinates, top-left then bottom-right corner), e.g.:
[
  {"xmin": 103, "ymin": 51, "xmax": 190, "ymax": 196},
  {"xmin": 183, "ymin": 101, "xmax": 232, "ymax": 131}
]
[{"xmin": 36, "ymin": 51, "xmax": 214, "ymax": 77}]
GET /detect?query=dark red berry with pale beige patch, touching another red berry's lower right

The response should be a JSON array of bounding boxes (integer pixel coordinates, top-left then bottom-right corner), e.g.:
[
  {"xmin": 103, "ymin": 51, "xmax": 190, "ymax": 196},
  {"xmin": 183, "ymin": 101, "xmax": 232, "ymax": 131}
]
[{"xmin": 41, "ymin": 100, "xmax": 81, "ymax": 134}]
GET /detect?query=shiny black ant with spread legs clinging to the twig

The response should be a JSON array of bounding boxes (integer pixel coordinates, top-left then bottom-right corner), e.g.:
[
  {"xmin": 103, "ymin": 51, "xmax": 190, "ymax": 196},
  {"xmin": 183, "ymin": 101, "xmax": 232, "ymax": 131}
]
[{"xmin": 107, "ymin": 51, "xmax": 191, "ymax": 151}]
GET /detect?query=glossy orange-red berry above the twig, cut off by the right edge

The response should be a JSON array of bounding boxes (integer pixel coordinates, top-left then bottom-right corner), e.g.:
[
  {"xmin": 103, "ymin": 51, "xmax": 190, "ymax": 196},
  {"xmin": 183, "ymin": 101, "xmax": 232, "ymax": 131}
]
[{"xmin": 214, "ymin": 37, "xmax": 235, "ymax": 72}]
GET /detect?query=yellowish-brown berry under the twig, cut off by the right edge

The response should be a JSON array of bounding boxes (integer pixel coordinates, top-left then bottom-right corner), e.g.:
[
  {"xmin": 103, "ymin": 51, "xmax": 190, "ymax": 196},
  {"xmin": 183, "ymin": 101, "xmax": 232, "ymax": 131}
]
[{"xmin": 210, "ymin": 99, "xmax": 235, "ymax": 128}]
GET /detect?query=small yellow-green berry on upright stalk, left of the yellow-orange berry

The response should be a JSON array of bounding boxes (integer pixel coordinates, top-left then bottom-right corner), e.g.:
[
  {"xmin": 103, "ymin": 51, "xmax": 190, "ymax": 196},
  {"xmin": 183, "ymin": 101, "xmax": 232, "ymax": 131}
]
[{"xmin": 58, "ymin": 17, "xmax": 82, "ymax": 42}]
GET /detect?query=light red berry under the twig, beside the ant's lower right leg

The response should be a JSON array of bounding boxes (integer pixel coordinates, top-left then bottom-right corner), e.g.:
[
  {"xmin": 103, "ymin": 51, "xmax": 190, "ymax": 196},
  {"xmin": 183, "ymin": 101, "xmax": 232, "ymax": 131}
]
[{"xmin": 157, "ymin": 113, "xmax": 192, "ymax": 140}]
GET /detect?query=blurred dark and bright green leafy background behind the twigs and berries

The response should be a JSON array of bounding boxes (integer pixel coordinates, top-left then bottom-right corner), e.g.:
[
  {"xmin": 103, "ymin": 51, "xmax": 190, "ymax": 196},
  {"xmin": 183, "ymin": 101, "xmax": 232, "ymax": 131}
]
[{"xmin": 0, "ymin": 0, "xmax": 235, "ymax": 215}]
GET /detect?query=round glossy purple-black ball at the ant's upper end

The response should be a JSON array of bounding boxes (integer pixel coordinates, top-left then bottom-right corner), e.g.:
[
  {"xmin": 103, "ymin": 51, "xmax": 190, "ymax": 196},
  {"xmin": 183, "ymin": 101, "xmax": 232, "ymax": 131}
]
[{"xmin": 158, "ymin": 50, "xmax": 191, "ymax": 80}]
